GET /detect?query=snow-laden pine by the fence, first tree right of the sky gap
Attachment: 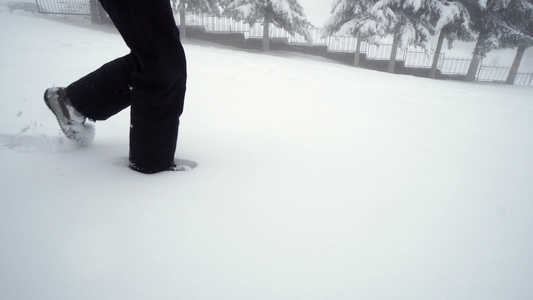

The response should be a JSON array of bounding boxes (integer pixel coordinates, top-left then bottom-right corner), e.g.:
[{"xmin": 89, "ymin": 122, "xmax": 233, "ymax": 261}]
[{"xmin": 323, "ymin": 0, "xmax": 385, "ymax": 67}]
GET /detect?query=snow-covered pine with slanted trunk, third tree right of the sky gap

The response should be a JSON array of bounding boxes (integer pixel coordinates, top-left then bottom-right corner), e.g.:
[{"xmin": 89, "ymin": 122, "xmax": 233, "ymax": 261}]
[{"xmin": 429, "ymin": 1, "xmax": 475, "ymax": 79}]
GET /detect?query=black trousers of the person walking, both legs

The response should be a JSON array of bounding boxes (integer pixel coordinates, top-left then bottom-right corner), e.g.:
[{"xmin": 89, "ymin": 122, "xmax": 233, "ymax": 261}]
[{"xmin": 67, "ymin": 0, "xmax": 187, "ymax": 173}]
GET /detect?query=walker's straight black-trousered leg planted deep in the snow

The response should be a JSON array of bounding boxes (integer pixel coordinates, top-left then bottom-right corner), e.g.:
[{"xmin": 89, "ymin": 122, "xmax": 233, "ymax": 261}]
[{"xmin": 100, "ymin": 0, "xmax": 187, "ymax": 173}]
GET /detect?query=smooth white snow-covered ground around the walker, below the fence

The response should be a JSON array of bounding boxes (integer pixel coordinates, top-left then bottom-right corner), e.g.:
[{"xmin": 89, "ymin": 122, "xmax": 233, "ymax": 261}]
[{"xmin": 0, "ymin": 8, "xmax": 533, "ymax": 300}]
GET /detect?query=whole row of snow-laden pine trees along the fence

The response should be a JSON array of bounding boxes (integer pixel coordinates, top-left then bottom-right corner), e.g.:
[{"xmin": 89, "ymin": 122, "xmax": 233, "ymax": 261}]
[{"xmin": 172, "ymin": 0, "xmax": 533, "ymax": 84}]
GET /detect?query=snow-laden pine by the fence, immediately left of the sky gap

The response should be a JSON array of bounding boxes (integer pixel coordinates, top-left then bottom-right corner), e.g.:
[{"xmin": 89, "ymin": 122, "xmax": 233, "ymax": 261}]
[{"xmin": 222, "ymin": 0, "xmax": 312, "ymax": 51}]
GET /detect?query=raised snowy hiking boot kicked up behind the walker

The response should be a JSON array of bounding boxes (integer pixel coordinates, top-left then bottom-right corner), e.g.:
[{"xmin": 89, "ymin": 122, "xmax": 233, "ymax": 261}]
[{"xmin": 44, "ymin": 87, "xmax": 94, "ymax": 144}]
